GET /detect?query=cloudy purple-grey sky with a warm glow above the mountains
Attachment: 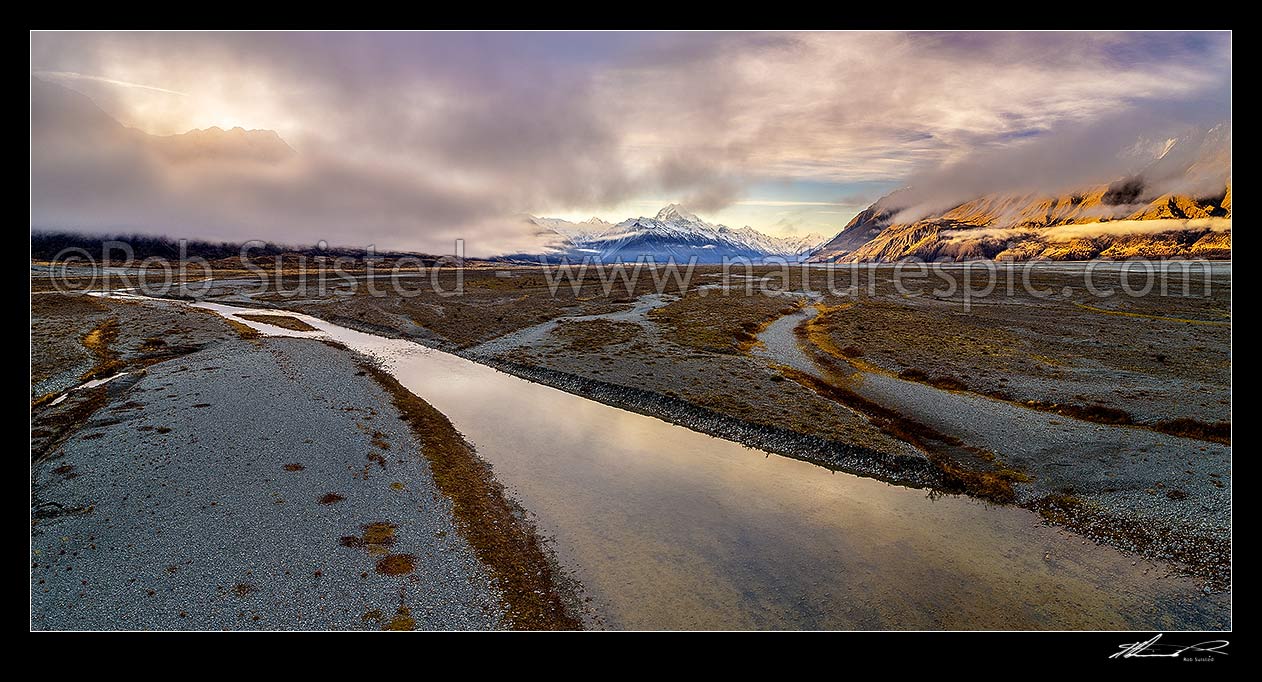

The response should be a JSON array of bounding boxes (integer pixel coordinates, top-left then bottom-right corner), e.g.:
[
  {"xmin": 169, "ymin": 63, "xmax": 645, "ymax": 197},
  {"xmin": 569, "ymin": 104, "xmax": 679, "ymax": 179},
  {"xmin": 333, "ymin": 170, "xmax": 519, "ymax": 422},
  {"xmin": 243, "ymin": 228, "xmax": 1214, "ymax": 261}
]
[{"xmin": 30, "ymin": 33, "xmax": 1232, "ymax": 254}]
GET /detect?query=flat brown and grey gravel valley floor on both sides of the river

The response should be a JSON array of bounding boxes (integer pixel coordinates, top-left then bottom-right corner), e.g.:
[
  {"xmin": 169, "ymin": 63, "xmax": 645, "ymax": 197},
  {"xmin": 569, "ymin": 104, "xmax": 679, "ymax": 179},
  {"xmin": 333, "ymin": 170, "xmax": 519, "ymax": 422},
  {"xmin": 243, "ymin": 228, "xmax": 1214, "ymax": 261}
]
[{"xmin": 32, "ymin": 265, "xmax": 1230, "ymax": 628}]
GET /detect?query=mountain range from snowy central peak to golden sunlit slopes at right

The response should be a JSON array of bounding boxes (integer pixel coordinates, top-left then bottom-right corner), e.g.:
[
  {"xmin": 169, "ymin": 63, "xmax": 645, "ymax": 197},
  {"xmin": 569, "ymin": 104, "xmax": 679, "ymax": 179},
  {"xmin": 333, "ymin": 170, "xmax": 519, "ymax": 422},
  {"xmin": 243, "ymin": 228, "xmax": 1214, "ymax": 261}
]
[{"xmin": 506, "ymin": 124, "xmax": 1232, "ymax": 263}]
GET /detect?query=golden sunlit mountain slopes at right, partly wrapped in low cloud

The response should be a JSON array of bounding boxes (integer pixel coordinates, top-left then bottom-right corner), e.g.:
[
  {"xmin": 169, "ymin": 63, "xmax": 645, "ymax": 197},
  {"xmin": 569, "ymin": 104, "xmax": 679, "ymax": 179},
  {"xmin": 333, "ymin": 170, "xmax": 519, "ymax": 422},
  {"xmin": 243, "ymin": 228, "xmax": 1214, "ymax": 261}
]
[{"xmin": 810, "ymin": 125, "xmax": 1232, "ymax": 263}]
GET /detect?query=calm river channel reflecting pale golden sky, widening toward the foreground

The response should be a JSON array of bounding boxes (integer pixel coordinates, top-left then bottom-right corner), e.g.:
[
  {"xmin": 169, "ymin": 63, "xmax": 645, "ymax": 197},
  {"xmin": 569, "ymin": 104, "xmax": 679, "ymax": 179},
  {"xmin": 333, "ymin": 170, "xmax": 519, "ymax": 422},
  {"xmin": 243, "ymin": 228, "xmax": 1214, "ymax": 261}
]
[{"xmin": 197, "ymin": 303, "xmax": 1227, "ymax": 629}]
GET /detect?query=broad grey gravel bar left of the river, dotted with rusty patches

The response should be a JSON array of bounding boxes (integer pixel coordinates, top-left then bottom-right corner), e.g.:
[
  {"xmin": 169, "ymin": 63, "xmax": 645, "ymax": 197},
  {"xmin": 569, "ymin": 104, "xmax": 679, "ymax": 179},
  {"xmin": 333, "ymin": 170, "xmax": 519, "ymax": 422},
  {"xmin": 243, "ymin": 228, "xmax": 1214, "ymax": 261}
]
[{"xmin": 32, "ymin": 338, "xmax": 502, "ymax": 630}]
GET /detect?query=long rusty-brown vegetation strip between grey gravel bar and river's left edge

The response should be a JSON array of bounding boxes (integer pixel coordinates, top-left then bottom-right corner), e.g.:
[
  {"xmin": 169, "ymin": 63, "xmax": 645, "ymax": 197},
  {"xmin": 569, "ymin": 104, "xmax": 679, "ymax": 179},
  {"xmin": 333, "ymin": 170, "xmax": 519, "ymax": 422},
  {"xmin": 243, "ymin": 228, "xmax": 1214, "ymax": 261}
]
[{"xmin": 365, "ymin": 365, "xmax": 582, "ymax": 630}]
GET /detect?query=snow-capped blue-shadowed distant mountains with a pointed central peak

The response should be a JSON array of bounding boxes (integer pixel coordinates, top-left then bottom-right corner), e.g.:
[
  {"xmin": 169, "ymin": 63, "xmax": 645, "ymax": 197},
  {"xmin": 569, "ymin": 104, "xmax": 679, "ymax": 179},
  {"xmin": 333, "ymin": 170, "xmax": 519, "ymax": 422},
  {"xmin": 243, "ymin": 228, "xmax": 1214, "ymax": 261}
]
[{"xmin": 502, "ymin": 203, "xmax": 825, "ymax": 263}]
